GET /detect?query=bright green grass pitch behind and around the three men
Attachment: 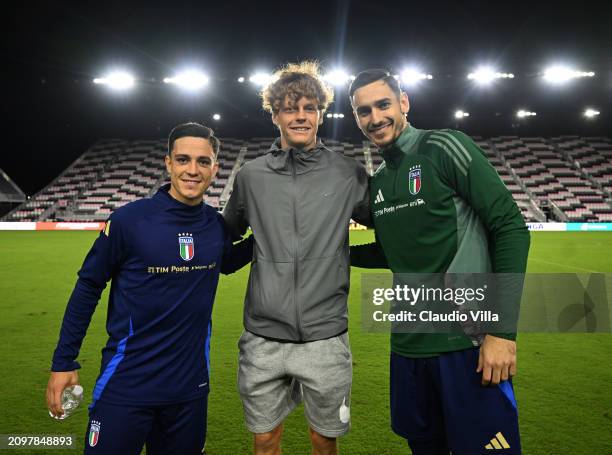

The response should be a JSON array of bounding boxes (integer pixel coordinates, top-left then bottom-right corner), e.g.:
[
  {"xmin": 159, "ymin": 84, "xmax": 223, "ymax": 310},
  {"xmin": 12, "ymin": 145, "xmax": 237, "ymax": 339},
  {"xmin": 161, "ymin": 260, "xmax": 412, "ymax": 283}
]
[{"xmin": 0, "ymin": 232, "xmax": 612, "ymax": 455}]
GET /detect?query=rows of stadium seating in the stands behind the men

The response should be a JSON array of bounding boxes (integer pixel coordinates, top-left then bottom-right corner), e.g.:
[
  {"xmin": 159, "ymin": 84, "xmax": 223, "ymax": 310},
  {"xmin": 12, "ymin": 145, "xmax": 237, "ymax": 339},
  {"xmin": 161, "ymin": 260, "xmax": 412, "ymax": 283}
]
[{"xmin": 0, "ymin": 136, "xmax": 612, "ymax": 222}]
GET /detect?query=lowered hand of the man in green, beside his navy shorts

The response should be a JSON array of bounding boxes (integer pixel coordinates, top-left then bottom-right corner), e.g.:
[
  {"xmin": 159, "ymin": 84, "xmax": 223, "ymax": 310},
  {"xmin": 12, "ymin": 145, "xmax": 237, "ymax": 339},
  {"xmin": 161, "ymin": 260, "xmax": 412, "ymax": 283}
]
[{"xmin": 476, "ymin": 335, "xmax": 516, "ymax": 386}]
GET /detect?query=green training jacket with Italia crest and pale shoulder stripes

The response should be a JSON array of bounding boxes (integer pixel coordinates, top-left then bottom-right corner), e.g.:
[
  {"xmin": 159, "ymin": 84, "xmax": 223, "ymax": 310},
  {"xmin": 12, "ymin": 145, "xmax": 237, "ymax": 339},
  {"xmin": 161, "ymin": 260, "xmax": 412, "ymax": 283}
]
[{"xmin": 351, "ymin": 125, "xmax": 529, "ymax": 357}]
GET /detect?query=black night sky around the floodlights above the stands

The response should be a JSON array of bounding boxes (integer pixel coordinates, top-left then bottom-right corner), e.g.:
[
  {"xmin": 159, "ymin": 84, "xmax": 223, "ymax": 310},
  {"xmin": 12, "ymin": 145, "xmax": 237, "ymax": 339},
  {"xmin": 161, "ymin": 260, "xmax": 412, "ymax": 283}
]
[{"xmin": 0, "ymin": 1, "xmax": 612, "ymax": 194}]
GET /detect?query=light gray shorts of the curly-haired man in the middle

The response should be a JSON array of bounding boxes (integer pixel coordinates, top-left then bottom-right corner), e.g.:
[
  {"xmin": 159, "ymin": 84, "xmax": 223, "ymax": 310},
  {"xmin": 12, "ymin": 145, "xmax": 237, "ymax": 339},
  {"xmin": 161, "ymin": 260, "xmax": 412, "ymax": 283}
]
[{"xmin": 238, "ymin": 331, "xmax": 353, "ymax": 438}]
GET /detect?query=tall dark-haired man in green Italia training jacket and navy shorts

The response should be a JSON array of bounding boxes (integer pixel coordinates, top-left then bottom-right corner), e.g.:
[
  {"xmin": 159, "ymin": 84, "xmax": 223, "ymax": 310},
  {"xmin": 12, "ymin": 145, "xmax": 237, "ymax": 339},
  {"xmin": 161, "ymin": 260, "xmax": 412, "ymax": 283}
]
[{"xmin": 349, "ymin": 70, "xmax": 529, "ymax": 455}]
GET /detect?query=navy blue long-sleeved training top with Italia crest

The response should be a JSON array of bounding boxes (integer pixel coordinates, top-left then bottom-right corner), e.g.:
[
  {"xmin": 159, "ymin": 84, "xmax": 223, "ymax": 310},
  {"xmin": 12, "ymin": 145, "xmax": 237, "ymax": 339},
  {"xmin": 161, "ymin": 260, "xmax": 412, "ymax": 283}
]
[{"xmin": 51, "ymin": 185, "xmax": 253, "ymax": 406}]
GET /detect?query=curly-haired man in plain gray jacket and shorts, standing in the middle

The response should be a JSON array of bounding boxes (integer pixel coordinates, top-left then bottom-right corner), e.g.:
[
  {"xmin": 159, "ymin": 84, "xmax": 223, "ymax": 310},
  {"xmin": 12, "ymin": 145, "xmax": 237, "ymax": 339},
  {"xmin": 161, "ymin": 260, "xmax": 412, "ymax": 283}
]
[{"xmin": 223, "ymin": 62, "xmax": 371, "ymax": 455}]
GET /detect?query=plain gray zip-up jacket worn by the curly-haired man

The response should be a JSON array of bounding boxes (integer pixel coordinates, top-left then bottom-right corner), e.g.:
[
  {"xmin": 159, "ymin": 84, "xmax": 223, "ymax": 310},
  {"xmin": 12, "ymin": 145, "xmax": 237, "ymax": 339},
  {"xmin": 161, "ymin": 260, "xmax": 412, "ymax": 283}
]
[{"xmin": 223, "ymin": 139, "xmax": 371, "ymax": 342}]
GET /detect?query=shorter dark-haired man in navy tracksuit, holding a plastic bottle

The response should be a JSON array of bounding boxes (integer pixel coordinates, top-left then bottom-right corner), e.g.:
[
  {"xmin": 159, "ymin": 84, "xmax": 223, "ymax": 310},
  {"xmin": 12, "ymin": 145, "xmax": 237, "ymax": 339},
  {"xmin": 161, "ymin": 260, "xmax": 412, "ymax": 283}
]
[{"xmin": 47, "ymin": 123, "xmax": 252, "ymax": 455}]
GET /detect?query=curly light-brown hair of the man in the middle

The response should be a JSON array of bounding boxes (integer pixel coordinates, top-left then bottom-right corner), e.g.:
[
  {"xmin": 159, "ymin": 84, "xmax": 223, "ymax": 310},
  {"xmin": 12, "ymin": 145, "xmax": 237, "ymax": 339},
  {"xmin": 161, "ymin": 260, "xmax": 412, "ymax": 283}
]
[{"xmin": 261, "ymin": 60, "xmax": 334, "ymax": 114}]
